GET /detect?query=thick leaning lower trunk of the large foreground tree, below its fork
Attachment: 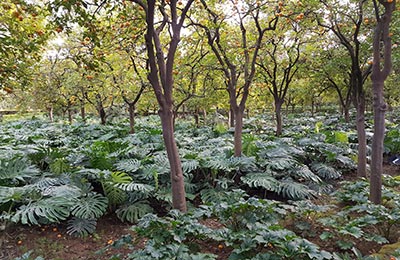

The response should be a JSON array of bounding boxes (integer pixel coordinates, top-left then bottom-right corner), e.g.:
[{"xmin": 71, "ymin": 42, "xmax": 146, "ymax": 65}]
[{"xmin": 159, "ymin": 109, "xmax": 187, "ymax": 212}]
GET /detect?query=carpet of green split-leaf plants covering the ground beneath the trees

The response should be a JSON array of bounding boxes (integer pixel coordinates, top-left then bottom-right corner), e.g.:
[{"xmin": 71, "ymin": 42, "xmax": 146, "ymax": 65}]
[{"xmin": 0, "ymin": 112, "xmax": 400, "ymax": 259}]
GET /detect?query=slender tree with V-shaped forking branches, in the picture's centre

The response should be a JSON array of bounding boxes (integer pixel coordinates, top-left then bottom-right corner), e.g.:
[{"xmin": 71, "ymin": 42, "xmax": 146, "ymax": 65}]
[{"xmin": 195, "ymin": 0, "xmax": 278, "ymax": 157}]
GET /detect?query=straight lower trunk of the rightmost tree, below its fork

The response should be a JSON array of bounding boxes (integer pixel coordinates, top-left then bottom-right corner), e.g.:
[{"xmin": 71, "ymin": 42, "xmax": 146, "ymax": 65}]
[{"xmin": 370, "ymin": 81, "xmax": 387, "ymax": 204}]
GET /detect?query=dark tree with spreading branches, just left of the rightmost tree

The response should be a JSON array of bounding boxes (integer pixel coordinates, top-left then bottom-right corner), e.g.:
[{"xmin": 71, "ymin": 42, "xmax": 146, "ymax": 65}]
[{"xmin": 316, "ymin": 0, "xmax": 372, "ymax": 177}]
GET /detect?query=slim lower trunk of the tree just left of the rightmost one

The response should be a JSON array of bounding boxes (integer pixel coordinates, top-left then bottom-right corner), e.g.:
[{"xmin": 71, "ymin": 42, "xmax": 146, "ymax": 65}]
[{"xmin": 356, "ymin": 94, "xmax": 367, "ymax": 177}]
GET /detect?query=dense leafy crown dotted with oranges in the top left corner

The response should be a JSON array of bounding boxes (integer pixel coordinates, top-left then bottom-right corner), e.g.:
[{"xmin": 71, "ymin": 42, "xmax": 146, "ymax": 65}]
[{"xmin": 0, "ymin": 0, "xmax": 50, "ymax": 92}]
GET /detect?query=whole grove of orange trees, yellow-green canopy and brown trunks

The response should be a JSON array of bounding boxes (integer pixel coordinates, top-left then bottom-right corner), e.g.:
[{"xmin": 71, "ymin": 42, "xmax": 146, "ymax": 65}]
[{"xmin": 0, "ymin": 0, "xmax": 400, "ymax": 256}]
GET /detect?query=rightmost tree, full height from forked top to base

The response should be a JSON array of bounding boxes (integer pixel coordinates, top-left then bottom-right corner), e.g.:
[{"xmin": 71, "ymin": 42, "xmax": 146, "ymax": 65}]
[{"xmin": 370, "ymin": 0, "xmax": 396, "ymax": 204}]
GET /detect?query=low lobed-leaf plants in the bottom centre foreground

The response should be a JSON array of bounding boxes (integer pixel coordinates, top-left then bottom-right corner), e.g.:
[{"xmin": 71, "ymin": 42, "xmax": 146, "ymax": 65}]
[{"xmin": 110, "ymin": 198, "xmax": 331, "ymax": 259}]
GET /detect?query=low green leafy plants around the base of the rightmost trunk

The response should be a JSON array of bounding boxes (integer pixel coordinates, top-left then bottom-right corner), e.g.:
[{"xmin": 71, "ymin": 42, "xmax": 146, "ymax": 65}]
[{"xmin": 319, "ymin": 176, "xmax": 400, "ymax": 249}]
